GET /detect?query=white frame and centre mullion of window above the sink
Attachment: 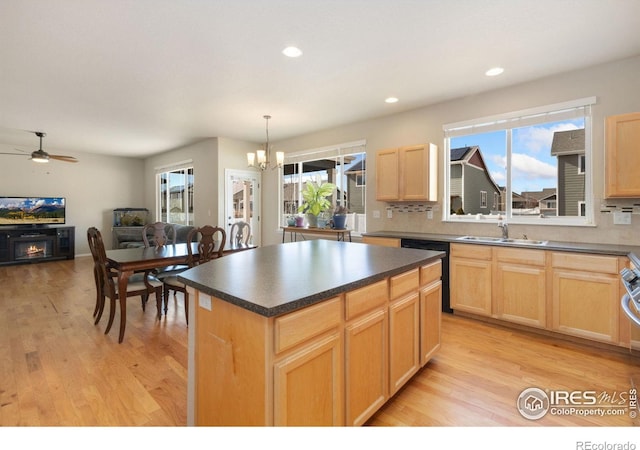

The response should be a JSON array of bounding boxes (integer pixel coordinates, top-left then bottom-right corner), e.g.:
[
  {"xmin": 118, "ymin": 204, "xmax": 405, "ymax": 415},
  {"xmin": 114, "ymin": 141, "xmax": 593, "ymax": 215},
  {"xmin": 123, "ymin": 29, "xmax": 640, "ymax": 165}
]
[{"xmin": 442, "ymin": 97, "xmax": 596, "ymax": 226}]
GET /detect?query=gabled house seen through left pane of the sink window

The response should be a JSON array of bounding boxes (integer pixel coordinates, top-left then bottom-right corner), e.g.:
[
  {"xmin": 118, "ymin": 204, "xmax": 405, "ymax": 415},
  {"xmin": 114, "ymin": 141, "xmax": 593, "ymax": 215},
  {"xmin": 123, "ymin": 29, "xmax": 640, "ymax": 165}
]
[{"xmin": 450, "ymin": 145, "xmax": 504, "ymax": 214}]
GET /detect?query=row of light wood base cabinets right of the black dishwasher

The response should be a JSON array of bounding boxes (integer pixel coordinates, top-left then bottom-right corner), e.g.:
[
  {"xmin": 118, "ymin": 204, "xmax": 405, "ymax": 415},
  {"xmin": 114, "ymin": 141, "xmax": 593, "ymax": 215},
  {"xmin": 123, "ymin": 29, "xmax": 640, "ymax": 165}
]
[{"xmin": 451, "ymin": 244, "xmax": 634, "ymax": 346}]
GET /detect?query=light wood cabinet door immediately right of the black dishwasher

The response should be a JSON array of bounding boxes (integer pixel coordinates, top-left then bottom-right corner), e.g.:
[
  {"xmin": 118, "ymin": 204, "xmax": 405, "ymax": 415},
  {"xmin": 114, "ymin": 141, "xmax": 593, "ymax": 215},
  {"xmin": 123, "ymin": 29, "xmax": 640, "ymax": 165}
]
[{"xmin": 449, "ymin": 257, "xmax": 491, "ymax": 316}]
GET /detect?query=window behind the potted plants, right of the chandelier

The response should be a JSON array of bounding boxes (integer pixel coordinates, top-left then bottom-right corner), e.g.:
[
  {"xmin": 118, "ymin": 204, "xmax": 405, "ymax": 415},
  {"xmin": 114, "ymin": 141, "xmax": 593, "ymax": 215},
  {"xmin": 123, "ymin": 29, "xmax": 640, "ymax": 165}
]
[{"xmin": 280, "ymin": 141, "xmax": 367, "ymax": 234}]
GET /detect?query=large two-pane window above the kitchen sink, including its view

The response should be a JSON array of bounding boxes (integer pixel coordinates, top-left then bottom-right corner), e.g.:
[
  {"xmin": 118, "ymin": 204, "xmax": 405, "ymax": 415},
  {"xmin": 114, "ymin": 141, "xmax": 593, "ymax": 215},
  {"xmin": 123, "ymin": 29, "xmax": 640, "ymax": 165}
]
[{"xmin": 443, "ymin": 98, "xmax": 595, "ymax": 225}]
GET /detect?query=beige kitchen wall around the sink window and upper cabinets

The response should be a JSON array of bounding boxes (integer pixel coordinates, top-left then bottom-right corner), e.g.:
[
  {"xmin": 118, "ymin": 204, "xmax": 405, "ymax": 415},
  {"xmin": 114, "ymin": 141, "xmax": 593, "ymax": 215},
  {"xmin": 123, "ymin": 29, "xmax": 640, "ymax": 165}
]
[{"xmin": 263, "ymin": 57, "xmax": 640, "ymax": 245}]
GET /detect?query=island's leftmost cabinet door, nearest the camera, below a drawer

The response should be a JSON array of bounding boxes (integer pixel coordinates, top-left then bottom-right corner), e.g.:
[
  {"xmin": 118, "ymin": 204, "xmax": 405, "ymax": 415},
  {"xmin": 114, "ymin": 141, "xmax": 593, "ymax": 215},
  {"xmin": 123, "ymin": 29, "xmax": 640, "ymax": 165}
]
[{"xmin": 273, "ymin": 333, "xmax": 344, "ymax": 426}]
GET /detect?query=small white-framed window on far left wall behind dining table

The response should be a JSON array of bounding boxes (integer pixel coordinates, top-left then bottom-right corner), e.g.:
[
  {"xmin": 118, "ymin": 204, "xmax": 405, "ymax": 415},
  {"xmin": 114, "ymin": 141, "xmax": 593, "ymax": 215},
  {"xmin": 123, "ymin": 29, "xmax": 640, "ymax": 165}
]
[{"xmin": 156, "ymin": 161, "xmax": 194, "ymax": 225}]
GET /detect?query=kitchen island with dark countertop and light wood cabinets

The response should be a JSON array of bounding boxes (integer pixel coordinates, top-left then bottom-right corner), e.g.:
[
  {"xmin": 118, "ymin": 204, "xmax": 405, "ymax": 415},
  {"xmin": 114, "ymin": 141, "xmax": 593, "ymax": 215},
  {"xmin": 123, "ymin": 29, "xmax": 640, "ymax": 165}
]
[{"xmin": 179, "ymin": 240, "xmax": 444, "ymax": 426}]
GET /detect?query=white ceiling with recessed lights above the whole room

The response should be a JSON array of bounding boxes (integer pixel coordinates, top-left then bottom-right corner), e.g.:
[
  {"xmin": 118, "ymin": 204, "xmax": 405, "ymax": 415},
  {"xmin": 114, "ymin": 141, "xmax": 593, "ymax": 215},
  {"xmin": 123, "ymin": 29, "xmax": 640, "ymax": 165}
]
[{"xmin": 0, "ymin": 0, "xmax": 640, "ymax": 159}]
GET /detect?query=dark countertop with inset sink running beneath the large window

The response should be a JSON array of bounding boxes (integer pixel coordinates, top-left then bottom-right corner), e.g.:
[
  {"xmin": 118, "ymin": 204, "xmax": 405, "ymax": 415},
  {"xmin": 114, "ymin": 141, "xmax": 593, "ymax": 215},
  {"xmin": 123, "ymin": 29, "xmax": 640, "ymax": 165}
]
[{"xmin": 364, "ymin": 231, "xmax": 640, "ymax": 256}]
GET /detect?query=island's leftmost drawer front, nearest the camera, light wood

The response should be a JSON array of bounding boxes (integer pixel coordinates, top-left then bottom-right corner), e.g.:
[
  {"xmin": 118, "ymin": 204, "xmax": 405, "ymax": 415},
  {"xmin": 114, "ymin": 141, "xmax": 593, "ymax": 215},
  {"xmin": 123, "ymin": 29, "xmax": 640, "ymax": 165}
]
[{"xmin": 275, "ymin": 297, "xmax": 342, "ymax": 353}]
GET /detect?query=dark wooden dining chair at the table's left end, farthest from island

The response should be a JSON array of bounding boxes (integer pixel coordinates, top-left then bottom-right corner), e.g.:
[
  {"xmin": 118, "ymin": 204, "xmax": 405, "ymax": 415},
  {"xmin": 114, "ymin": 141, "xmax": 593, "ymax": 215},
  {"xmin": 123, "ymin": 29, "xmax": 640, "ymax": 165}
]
[{"xmin": 87, "ymin": 227, "xmax": 163, "ymax": 342}]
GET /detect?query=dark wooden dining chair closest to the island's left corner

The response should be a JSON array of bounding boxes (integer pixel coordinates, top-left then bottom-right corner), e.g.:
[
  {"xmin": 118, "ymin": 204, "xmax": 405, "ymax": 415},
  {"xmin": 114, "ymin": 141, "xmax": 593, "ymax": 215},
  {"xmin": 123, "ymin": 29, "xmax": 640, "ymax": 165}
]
[{"xmin": 162, "ymin": 225, "xmax": 227, "ymax": 325}]
